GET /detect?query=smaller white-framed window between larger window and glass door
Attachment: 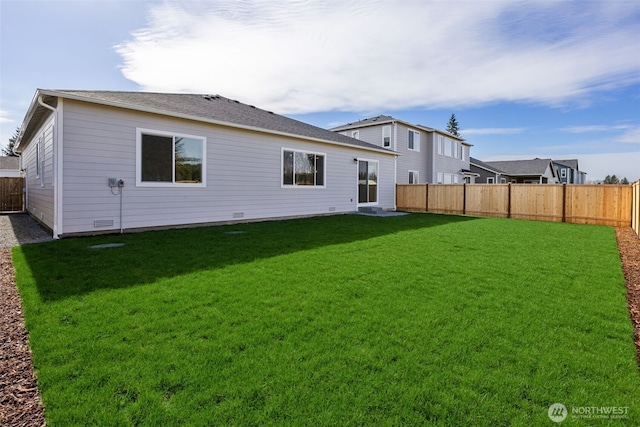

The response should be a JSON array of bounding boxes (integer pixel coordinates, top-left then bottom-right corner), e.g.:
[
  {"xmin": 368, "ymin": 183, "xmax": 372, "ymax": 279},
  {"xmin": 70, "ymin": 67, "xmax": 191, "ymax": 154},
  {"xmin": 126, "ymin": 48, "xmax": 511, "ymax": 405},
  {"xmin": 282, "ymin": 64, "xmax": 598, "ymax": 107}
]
[{"xmin": 282, "ymin": 150, "xmax": 325, "ymax": 187}]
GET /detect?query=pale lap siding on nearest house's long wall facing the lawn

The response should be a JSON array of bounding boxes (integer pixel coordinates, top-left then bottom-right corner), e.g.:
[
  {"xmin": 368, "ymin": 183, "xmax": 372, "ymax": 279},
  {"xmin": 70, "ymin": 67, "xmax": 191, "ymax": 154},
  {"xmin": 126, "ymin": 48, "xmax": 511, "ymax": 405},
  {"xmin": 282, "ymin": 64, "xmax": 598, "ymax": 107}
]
[{"xmin": 57, "ymin": 100, "xmax": 395, "ymax": 235}]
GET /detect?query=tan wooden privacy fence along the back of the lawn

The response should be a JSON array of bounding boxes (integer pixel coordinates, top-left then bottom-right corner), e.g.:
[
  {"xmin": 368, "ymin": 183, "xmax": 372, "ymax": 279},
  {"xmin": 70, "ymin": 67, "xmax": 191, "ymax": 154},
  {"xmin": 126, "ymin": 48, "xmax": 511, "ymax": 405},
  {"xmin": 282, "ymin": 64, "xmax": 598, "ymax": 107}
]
[{"xmin": 396, "ymin": 183, "xmax": 638, "ymax": 227}]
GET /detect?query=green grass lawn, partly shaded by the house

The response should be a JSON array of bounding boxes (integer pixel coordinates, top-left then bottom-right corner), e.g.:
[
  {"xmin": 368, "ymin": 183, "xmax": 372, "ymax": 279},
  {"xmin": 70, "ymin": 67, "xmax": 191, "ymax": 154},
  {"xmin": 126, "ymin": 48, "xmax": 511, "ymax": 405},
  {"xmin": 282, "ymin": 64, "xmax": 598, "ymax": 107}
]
[{"xmin": 13, "ymin": 214, "xmax": 640, "ymax": 426}]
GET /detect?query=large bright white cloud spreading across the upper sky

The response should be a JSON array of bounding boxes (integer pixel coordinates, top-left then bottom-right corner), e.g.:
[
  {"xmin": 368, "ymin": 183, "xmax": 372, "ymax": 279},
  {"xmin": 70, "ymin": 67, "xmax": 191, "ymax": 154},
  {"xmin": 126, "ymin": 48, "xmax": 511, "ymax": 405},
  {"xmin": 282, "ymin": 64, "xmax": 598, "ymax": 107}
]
[{"xmin": 116, "ymin": 0, "xmax": 640, "ymax": 114}]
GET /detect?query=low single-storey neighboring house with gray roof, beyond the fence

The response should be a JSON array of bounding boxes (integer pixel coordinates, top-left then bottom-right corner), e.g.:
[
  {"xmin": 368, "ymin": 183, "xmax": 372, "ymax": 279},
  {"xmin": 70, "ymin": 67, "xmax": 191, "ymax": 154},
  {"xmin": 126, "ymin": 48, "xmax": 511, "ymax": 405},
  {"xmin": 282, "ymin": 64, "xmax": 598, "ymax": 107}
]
[{"xmin": 484, "ymin": 158, "xmax": 560, "ymax": 184}]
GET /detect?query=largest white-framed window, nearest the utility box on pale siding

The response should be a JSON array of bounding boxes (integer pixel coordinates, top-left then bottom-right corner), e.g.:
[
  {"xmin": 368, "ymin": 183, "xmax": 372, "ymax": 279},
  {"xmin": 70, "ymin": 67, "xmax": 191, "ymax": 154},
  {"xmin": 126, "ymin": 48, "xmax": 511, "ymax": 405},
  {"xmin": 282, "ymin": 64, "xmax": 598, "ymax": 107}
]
[{"xmin": 137, "ymin": 129, "xmax": 205, "ymax": 186}]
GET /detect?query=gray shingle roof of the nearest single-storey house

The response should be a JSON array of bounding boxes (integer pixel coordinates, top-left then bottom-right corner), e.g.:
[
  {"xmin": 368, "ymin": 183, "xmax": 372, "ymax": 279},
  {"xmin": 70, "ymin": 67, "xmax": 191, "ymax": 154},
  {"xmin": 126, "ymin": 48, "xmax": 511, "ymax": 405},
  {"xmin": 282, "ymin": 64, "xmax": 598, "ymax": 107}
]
[{"xmin": 36, "ymin": 90, "xmax": 391, "ymax": 153}]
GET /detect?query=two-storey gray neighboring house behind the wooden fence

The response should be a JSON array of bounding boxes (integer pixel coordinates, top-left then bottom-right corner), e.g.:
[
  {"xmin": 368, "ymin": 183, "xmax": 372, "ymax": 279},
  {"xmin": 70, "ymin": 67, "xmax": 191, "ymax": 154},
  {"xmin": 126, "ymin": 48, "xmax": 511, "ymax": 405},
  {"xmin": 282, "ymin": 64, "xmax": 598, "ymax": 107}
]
[{"xmin": 331, "ymin": 115, "xmax": 476, "ymax": 184}]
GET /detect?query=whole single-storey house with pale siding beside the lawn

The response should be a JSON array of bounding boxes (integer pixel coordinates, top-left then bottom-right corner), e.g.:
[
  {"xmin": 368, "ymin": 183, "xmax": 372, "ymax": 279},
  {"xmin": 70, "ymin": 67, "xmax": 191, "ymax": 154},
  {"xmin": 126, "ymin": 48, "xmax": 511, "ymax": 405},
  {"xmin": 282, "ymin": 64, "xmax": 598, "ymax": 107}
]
[{"xmin": 16, "ymin": 89, "xmax": 396, "ymax": 238}]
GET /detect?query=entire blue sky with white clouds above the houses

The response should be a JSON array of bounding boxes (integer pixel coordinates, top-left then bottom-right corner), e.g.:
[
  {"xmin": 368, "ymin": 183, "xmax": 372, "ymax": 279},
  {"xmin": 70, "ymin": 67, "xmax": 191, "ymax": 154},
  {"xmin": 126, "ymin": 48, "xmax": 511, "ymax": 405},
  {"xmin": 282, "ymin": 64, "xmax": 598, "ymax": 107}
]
[{"xmin": 0, "ymin": 0, "xmax": 640, "ymax": 180}]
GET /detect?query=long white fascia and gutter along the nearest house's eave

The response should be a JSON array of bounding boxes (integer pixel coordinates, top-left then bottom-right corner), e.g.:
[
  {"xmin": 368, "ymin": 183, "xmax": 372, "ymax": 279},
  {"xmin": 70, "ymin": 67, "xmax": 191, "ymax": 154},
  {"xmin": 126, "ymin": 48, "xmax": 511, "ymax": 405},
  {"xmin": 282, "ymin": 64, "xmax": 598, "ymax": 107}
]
[{"xmin": 42, "ymin": 90, "xmax": 396, "ymax": 155}]
